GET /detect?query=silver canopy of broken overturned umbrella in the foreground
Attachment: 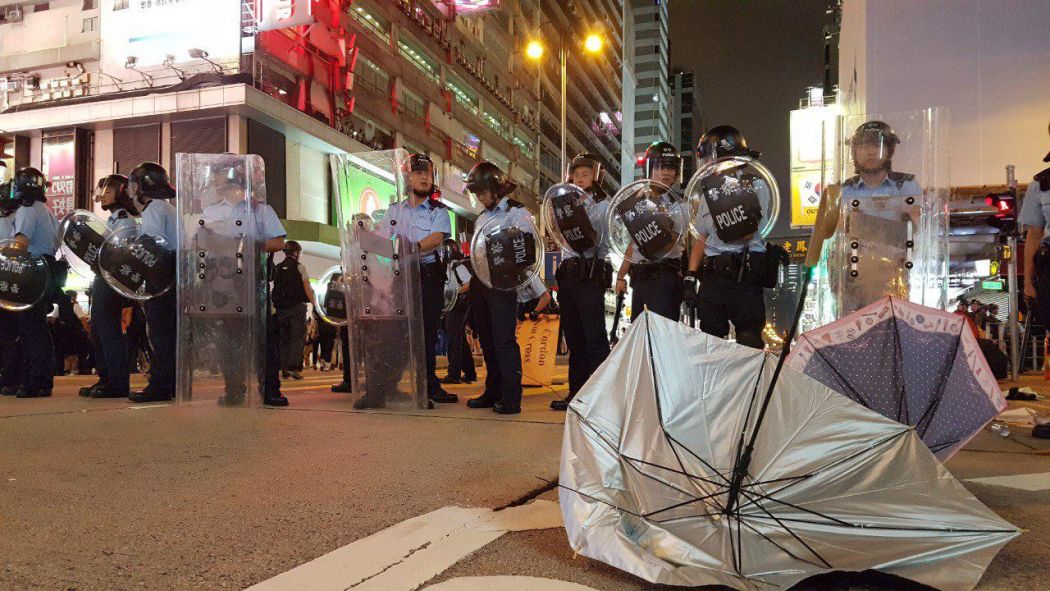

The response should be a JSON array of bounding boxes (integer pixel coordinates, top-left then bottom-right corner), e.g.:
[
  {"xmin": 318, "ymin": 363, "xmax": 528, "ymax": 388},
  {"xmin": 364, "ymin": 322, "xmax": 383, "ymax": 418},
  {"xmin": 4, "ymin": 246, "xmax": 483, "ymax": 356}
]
[{"xmin": 560, "ymin": 312, "xmax": 1017, "ymax": 591}]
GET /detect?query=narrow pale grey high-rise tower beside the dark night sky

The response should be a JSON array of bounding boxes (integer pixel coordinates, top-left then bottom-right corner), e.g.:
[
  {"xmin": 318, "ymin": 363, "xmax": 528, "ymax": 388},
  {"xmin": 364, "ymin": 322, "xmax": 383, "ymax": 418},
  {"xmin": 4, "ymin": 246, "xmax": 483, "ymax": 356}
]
[{"xmin": 627, "ymin": 0, "xmax": 671, "ymax": 175}]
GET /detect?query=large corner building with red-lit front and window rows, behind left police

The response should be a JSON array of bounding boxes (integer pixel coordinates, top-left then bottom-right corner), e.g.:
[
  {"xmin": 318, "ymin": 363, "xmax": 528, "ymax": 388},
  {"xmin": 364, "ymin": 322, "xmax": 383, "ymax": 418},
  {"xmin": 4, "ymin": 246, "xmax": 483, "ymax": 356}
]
[{"xmin": 0, "ymin": 0, "xmax": 623, "ymax": 276}]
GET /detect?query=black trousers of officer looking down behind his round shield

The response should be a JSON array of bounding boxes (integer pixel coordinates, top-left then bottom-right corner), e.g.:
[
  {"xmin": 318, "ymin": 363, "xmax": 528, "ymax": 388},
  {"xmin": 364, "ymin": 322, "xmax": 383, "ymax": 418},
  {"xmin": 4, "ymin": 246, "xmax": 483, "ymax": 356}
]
[{"xmin": 470, "ymin": 281, "xmax": 522, "ymax": 407}]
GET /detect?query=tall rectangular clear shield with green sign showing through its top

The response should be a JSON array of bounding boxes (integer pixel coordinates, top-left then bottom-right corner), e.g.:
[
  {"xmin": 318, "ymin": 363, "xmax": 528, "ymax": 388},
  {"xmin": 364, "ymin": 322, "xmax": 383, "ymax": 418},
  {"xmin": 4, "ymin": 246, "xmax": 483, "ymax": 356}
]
[{"xmin": 331, "ymin": 150, "xmax": 428, "ymax": 409}]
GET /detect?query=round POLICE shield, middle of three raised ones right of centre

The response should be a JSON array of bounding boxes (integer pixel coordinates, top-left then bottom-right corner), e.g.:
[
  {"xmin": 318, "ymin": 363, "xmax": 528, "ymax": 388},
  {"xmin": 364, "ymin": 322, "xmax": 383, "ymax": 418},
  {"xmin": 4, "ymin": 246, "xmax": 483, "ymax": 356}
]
[{"xmin": 607, "ymin": 178, "xmax": 689, "ymax": 262}]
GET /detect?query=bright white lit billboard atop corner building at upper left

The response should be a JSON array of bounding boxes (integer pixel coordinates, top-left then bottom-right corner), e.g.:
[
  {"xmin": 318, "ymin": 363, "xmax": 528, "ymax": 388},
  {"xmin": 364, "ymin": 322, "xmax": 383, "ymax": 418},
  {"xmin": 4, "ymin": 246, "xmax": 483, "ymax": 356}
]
[{"xmin": 100, "ymin": 0, "xmax": 240, "ymax": 82}]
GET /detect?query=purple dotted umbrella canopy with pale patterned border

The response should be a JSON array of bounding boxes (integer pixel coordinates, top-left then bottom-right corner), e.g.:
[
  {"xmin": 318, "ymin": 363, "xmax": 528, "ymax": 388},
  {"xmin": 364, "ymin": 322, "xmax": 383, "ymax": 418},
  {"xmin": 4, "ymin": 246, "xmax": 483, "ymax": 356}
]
[{"xmin": 785, "ymin": 297, "xmax": 1006, "ymax": 461}]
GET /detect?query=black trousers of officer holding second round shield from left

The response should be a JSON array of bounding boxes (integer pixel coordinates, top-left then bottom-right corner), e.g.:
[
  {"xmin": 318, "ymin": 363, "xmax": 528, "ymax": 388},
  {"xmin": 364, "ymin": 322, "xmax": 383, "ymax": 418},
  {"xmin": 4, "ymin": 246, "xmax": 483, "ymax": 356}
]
[{"xmin": 91, "ymin": 275, "xmax": 131, "ymax": 394}]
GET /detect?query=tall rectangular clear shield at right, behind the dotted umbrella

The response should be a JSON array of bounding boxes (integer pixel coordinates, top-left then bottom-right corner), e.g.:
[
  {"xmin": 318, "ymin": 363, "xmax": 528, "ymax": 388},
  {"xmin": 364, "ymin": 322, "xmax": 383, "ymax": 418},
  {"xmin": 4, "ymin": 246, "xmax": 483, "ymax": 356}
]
[{"xmin": 817, "ymin": 108, "xmax": 950, "ymax": 323}]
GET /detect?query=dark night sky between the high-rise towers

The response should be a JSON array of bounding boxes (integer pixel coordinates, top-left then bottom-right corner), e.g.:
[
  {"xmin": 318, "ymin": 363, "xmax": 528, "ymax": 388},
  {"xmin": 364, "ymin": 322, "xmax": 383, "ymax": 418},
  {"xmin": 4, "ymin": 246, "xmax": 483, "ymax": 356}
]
[{"xmin": 665, "ymin": 0, "xmax": 827, "ymax": 235}]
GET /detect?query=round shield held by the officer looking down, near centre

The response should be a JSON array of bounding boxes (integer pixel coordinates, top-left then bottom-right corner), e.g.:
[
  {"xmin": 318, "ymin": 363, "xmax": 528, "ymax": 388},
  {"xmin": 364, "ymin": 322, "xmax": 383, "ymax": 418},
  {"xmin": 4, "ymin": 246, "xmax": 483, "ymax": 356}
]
[{"xmin": 470, "ymin": 215, "xmax": 543, "ymax": 292}]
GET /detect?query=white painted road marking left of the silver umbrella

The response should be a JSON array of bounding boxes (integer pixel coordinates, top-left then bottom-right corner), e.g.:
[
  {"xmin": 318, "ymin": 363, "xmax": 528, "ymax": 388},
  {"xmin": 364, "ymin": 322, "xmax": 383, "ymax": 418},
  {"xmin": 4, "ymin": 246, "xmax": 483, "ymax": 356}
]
[{"xmin": 249, "ymin": 501, "xmax": 562, "ymax": 591}]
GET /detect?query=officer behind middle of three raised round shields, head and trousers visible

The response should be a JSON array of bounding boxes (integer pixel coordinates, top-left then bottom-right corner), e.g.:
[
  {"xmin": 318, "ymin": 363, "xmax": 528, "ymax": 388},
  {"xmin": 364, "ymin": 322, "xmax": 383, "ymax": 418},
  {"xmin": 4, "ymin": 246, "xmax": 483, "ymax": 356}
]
[{"xmin": 603, "ymin": 142, "xmax": 687, "ymax": 326}]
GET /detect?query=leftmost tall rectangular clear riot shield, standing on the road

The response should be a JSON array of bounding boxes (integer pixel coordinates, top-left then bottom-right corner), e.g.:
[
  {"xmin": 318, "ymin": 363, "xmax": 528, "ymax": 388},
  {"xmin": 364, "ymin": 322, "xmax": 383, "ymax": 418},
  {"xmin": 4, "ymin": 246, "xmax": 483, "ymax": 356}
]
[{"xmin": 175, "ymin": 153, "xmax": 269, "ymax": 406}]
